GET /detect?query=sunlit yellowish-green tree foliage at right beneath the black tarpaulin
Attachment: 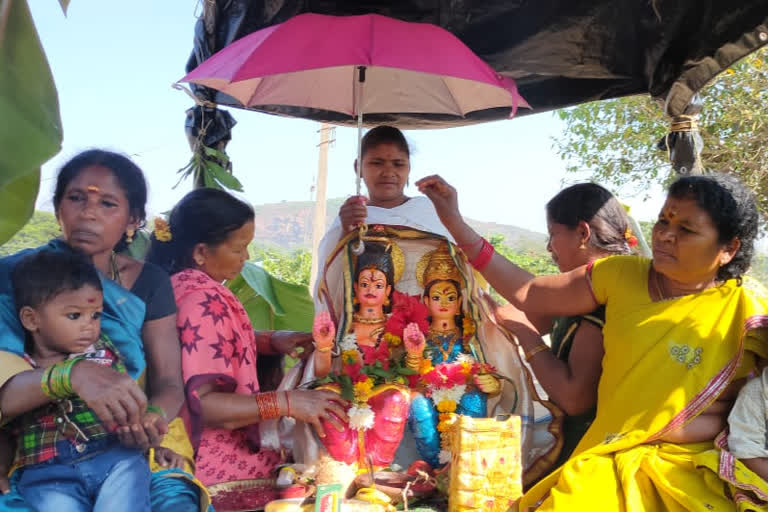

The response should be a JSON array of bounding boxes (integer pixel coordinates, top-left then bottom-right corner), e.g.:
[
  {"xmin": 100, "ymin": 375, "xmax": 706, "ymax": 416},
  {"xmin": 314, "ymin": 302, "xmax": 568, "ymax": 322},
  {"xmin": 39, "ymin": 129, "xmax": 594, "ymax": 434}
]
[{"xmin": 553, "ymin": 48, "xmax": 768, "ymax": 213}]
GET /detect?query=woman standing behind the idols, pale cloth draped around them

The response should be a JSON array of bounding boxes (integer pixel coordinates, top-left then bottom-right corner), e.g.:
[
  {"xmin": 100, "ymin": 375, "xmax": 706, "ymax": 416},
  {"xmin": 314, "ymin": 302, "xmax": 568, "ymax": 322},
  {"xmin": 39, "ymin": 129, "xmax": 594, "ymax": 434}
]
[{"xmin": 294, "ymin": 126, "xmax": 553, "ymax": 482}]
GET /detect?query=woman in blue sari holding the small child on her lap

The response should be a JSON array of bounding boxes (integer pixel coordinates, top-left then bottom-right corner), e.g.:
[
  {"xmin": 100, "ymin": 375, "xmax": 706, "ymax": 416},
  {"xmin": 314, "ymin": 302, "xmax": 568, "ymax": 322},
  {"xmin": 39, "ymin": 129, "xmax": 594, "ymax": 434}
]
[{"xmin": 0, "ymin": 150, "xmax": 207, "ymax": 510}]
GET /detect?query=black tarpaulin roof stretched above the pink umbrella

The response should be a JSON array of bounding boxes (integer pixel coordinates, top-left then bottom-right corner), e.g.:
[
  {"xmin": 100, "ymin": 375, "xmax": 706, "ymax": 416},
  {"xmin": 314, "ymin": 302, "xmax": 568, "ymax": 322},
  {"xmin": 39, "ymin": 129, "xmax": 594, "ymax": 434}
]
[{"xmin": 187, "ymin": 0, "xmax": 768, "ymax": 128}]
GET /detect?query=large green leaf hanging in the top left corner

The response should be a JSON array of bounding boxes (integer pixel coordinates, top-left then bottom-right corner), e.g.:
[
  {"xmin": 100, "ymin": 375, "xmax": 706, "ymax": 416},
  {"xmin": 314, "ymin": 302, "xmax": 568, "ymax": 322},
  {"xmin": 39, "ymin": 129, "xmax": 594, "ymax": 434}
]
[{"xmin": 0, "ymin": 0, "xmax": 62, "ymax": 192}]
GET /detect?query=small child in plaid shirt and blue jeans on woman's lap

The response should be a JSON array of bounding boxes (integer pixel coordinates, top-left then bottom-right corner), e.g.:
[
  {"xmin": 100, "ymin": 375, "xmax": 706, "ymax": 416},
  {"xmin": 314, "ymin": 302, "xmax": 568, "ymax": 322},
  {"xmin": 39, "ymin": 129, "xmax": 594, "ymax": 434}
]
[{"xmin": 0, "ymin": 250, "xmax": 154, "ymax": 512}]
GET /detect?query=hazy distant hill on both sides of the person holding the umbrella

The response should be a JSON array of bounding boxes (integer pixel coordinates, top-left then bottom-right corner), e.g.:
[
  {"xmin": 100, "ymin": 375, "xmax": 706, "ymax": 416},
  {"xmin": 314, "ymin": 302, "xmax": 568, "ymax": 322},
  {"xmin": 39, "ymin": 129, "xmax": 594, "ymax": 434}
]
[{"xmin": 255, "ymin": 198, "xmax": 547, "ymax": 252}]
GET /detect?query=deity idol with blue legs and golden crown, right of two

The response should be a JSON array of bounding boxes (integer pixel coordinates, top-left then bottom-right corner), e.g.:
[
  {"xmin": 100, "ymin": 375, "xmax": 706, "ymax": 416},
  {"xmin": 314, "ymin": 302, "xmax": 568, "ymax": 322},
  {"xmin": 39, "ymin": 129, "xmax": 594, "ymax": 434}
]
[{"xmin": 403, "ymin": 244, "xmax": 501, "ymax": 467}]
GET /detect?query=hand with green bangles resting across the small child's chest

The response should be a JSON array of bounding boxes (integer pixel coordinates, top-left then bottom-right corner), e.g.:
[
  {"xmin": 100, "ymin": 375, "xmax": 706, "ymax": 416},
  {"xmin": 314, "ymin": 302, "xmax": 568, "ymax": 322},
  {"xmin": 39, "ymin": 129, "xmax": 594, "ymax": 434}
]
[{"xmin": 70, "ymin": 361, "xmax": 147, "ymax": 431}]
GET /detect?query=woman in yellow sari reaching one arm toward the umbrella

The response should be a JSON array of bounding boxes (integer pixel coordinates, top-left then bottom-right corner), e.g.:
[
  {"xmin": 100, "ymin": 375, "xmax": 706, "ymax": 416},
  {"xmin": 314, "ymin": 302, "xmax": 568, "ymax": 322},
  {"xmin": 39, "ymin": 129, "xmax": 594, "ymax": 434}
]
[{"xmin": 417, "ymin": 175, "xmax": 768, "ymax": 511}]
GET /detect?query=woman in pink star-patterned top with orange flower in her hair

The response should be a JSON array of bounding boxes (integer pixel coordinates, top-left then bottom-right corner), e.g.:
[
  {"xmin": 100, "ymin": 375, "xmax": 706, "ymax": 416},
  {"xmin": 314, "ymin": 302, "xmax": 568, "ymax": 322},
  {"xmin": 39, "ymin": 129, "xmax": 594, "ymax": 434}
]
[{"xmin": 147, "ymin": 189, "xmax": 347, "ymax": 498}]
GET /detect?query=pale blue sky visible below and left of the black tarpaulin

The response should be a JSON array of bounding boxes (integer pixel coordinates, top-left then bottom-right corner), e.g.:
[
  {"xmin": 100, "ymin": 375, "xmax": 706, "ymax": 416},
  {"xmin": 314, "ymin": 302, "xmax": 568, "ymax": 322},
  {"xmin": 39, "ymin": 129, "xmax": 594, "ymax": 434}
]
[{"xmin": 29, "ymin": 0, "xmax": 661, "ymax": 236}]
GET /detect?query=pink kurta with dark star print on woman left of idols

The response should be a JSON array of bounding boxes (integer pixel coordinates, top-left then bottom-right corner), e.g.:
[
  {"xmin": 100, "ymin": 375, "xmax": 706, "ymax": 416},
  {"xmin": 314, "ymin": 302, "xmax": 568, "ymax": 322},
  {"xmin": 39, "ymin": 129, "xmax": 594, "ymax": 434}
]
[{"xmin": 171, "ymin": 269, "xmax": 282, "ymax": 485}]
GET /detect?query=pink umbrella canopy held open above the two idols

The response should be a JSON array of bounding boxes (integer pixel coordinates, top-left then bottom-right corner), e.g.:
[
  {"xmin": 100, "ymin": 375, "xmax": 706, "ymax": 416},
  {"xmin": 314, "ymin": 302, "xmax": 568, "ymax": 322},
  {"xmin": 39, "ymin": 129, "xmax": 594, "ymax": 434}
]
[{"xmin": 181, "ymin": 14, "xmax": 527, "ymax": 123}]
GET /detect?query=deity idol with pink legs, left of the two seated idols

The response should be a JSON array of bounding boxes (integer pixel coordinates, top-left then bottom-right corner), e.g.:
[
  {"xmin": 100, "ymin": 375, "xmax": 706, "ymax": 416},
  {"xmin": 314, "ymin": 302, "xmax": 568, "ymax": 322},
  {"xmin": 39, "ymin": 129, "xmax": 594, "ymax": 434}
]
[{"xmin": 313, "ymin": 240, "xmax": 418, "ymax": 467}]
